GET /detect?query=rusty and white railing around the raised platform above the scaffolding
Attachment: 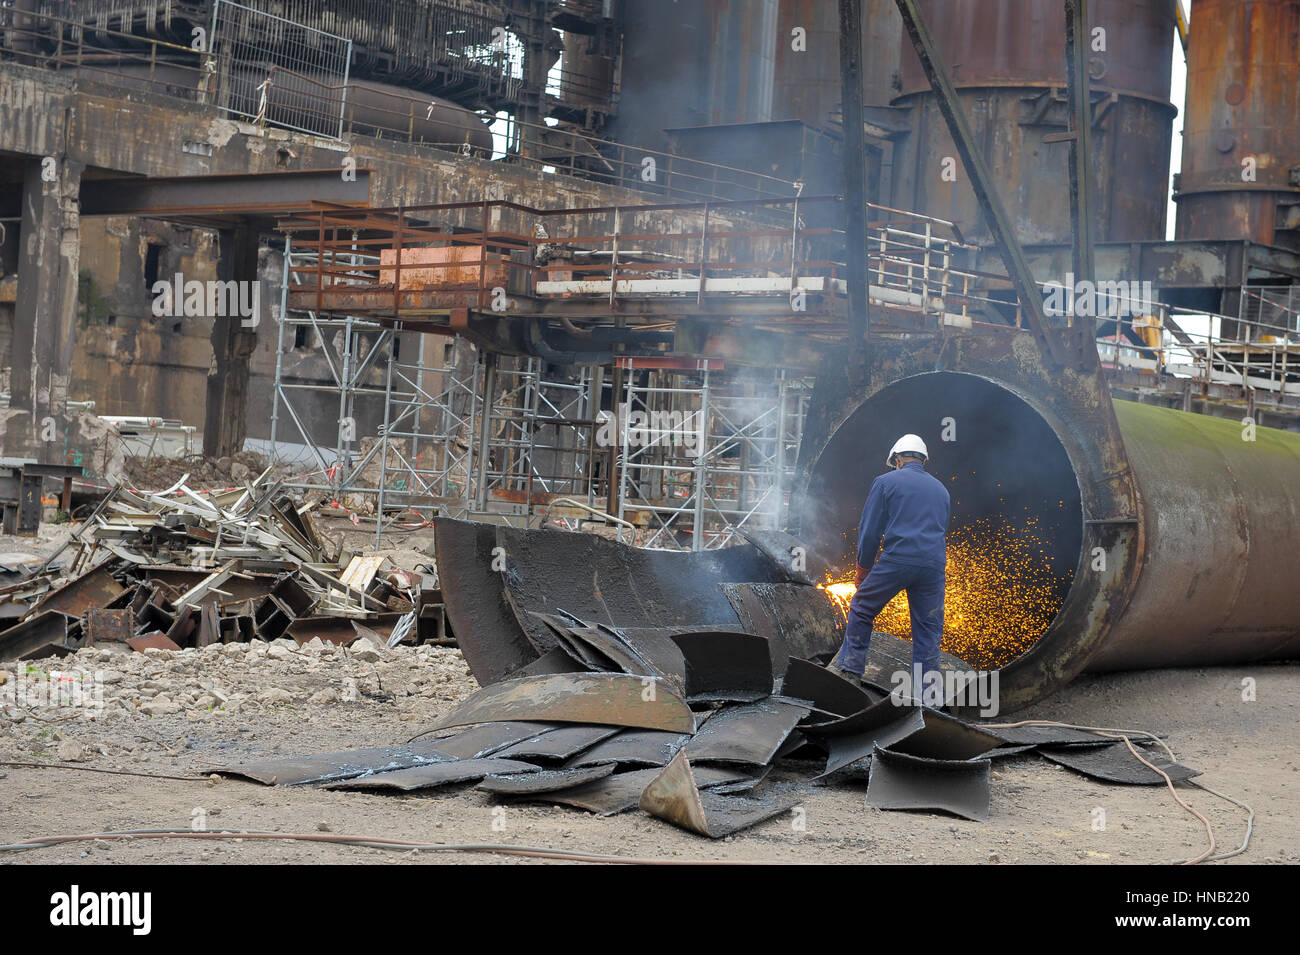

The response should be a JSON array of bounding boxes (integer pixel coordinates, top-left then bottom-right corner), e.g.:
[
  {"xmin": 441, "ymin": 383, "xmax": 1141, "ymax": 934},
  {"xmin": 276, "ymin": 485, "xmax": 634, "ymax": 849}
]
[{"xmin": 282, "ymin": 196, "xmax": 1018, "ymax": 325}]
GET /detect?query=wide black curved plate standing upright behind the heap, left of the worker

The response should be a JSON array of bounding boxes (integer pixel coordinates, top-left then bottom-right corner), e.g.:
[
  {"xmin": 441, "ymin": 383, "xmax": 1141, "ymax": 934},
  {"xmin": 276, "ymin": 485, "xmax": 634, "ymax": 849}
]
[{"xmin": 494, "ymin": 528, "xmax": 785, "ymax": 650}]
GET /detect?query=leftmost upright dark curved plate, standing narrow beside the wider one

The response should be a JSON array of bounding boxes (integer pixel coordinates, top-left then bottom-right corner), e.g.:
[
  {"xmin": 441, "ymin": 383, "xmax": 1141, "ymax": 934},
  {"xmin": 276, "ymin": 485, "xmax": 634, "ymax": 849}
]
[{"xmin": 433, "ymin": 517, "xmax": 540, "ymax": 686}]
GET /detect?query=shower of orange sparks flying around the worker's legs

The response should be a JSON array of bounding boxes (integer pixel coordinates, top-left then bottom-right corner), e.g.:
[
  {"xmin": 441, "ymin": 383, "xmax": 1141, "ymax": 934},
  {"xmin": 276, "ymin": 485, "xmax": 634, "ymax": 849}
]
[{"xmin": 819, "ymin": 520, "xmax": 1074, "ymax": 669}]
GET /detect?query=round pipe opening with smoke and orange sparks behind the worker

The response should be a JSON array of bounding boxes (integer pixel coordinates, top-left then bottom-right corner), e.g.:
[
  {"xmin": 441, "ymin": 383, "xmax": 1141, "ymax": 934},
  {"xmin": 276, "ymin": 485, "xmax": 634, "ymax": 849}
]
[{"xmin": 803, "ymin": 372, "xmax": 1083, "ymax": 669}]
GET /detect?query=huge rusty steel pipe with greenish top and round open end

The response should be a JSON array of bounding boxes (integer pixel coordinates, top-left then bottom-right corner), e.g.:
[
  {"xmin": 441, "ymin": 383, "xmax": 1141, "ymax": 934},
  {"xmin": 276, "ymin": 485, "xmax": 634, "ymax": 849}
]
[{"xmin": 803, "ymin": 372, "xmax": 1300, "ymax": 711}]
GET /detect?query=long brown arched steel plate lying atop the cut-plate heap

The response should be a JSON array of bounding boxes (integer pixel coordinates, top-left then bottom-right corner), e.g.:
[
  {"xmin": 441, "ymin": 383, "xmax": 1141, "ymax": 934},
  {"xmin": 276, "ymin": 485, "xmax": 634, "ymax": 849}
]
[{"xmin": 433, "ymin": 673, "xmax": 696, "ymax": 733}]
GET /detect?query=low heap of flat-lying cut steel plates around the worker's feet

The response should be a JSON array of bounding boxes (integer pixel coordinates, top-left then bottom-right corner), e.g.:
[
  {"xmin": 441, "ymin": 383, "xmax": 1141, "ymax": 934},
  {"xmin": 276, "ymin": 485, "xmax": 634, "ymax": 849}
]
[{"xmin": 216, "ymin": 612, "xmax": 1195, "ymax": 838}]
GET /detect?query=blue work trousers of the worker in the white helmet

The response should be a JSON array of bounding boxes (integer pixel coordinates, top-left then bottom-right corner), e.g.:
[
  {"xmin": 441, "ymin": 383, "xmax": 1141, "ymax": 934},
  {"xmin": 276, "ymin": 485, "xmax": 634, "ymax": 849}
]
[{"xmin": 836, "ymin": 557, "xmax": 944, "ymax": 680}]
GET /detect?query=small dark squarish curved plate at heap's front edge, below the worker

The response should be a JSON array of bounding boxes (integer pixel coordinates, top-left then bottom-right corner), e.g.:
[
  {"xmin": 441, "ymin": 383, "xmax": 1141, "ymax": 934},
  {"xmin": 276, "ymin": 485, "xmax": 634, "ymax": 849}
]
[{"xmin": 867, "ymin": 746, "xmax": 992, "ymax": 822}]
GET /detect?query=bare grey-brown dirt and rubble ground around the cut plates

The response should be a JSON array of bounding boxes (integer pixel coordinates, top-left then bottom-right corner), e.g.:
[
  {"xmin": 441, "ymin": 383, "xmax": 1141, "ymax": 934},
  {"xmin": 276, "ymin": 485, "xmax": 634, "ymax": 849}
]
[{"xmin": 0, "ymin": 530, "xmax": 1300, "ymax": 865}]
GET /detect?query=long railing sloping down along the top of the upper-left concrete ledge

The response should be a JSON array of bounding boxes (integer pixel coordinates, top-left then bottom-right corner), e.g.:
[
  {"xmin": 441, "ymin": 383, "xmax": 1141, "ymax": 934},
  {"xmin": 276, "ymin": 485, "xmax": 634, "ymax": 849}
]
[{"xmin": 0, "ymin": 3, "xmax": 797, "ymax": 200}]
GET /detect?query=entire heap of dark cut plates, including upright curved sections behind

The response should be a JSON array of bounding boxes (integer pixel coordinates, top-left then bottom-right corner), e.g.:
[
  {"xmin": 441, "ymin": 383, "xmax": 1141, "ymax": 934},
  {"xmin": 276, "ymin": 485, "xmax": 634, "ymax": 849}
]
[{"xmin": 217, "ymin": 521, "xmax": 1196, "ymax": 838}]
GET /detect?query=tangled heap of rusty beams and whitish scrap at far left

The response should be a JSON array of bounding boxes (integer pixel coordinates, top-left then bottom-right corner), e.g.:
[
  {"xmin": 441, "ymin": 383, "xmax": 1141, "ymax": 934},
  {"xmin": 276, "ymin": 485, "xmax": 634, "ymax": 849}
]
[{"xmin": 0, "ymin": 476, "xmax": 441, "ymax": 660}]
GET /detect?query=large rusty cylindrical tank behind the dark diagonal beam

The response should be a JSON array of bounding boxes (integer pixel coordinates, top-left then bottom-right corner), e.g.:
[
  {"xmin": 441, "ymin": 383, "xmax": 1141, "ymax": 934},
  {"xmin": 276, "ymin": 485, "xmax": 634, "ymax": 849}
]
[{"xmin": 891, "ymin": 0, "xmax": 1175, "ymax": 252}]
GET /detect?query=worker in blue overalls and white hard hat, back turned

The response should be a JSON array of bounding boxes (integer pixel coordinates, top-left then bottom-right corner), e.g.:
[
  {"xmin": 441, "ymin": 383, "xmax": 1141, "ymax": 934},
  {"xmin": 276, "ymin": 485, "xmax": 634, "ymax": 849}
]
[{"xmin": 828, "ymin": 434, "xmax": 950, "ymax": 702}]
